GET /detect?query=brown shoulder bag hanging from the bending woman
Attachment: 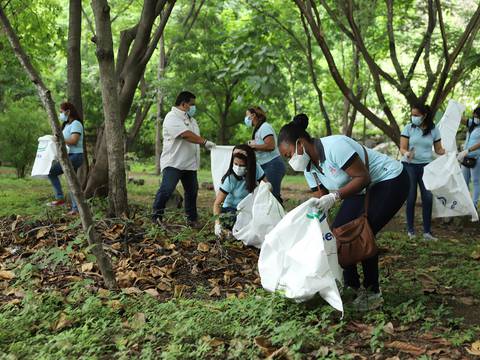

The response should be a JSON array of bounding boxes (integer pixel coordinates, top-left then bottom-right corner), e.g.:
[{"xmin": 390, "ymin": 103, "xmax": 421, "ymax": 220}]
[{"xmin": 332, "ymin": 147, "xmax": 378, "ymax": 268}]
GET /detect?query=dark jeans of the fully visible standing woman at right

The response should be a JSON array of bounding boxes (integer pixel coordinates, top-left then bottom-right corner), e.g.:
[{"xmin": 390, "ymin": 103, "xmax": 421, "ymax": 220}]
[{"xmin": 403, "ymin": 162, "xmax": 433, "ymax": 233}]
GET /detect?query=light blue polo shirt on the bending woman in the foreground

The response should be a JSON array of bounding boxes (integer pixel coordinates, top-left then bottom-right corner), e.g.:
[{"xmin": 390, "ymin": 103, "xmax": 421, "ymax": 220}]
[{"xmin": 304, "ymin": 135, "xmax": 403, "ymax": 191}]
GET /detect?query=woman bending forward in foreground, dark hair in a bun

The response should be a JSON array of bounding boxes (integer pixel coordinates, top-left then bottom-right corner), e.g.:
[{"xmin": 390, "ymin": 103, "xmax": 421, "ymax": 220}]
[{"xmin": 278, "ymin": 114, "xmax": 409, "ymax": 311}]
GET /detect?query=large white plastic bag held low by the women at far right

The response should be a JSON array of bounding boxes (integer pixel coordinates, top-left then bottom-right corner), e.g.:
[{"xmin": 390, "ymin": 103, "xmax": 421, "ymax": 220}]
[{"xmin": 423, "ymin": 153, "xmax": 478, "ymax": 221}]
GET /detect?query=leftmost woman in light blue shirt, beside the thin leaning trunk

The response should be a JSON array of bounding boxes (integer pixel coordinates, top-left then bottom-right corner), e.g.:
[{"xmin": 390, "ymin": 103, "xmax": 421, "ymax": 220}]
[{"xmin": 47, "ymin": 102, "xmax": 83, "ymax": 215}]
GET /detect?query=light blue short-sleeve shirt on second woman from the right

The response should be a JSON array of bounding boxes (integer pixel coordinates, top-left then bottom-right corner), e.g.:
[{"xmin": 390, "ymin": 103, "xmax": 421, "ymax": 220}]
[{"xmin": 401, "ymin": 123, "xmax": 441, "ymax": 164}]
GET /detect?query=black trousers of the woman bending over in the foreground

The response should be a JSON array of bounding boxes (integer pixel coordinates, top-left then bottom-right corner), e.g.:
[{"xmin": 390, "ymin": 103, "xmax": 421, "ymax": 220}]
[{"xmin": 332, "ymin": 169, "xmax": 410, "ymax": 292}]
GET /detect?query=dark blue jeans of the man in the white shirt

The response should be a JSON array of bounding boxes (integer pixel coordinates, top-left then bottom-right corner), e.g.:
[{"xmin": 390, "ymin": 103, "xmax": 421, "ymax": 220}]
[{"xmin": 152, "ymin": 167, "xmax": 198, "ymax": 221}]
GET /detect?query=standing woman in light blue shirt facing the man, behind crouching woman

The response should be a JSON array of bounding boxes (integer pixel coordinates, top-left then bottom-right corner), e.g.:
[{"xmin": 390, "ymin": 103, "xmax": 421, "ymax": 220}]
[{"xmin": 245, "ymin": 106, "xmax": 286, "ymax": 202}]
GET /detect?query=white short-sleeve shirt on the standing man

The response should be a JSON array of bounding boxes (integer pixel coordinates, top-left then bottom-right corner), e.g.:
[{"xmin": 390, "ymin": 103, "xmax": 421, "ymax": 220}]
[{"xmin": 160, "ymin": 107, "xmax": 200, "ymax": 171}]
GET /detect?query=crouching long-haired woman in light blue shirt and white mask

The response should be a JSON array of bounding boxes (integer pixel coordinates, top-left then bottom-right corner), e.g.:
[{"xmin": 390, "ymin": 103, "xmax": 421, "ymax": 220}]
[{"xmin": 213, "ymin": 145, "xmax": 271, "ymax": 237}]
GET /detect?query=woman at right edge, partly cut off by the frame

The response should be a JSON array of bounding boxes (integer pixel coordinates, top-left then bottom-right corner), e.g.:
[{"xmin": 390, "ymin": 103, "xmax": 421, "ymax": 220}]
[{"xmin": 457, "ymin": 107, "xmax": 480, "ymax": 207}]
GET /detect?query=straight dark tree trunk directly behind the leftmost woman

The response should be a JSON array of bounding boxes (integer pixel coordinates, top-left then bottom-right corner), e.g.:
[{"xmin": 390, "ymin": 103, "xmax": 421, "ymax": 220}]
[{"xmin": 67, "ymin": 0, "xmax": 89, "ymax": 188}]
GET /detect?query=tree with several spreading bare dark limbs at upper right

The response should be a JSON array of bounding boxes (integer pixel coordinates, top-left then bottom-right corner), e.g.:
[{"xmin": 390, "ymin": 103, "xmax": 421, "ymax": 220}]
[{"xmin": 294, "ymin": 0, "xmax": 480, "ymax": 145}]
